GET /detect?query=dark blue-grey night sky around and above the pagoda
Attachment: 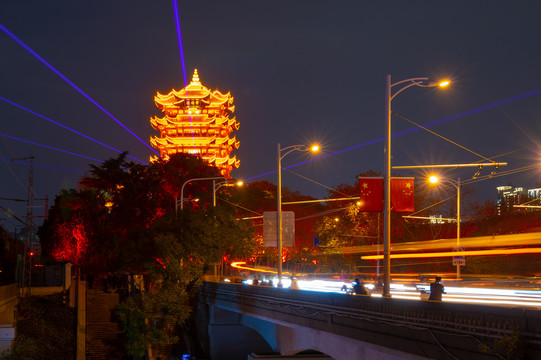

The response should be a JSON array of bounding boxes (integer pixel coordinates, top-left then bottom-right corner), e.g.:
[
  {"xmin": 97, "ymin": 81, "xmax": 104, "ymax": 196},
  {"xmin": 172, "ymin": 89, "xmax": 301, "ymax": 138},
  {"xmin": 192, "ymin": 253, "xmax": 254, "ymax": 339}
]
[{"xmin": 0, "ymin": 0, "xmax": 541, "ymax": 228}]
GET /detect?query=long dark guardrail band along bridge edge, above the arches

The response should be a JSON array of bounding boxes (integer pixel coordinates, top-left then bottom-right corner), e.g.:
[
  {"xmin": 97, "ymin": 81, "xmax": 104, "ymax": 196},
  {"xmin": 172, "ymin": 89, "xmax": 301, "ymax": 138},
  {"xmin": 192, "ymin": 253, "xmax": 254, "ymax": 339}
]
[{"xmin": 200, "ymin": 282, "xmax": 541, "ymax": 355}]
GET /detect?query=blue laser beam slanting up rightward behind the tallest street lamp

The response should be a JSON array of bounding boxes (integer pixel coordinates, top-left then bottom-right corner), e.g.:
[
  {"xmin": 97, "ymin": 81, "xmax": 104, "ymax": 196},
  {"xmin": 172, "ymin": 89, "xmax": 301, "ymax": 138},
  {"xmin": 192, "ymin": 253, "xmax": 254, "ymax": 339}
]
[{"xmin": 245, "ymin": 89, "xmax": 541, "ymax": 181}]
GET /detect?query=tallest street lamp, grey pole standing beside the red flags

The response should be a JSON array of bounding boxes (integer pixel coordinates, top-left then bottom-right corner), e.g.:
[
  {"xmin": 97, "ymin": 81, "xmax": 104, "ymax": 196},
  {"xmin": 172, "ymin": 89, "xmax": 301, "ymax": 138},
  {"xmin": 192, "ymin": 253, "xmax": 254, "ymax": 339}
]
[{"xmin": 382, "ymin": 74, "xmax": 449, "ymax": 297}]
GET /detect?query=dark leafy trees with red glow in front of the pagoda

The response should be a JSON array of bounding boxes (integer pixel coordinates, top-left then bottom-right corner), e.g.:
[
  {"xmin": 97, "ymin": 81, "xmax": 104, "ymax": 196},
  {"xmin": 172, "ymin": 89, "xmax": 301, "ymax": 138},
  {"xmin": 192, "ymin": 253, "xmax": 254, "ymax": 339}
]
[{"xmin": 40, "ymin": 154, "xmax": 252, "ymax": 355}]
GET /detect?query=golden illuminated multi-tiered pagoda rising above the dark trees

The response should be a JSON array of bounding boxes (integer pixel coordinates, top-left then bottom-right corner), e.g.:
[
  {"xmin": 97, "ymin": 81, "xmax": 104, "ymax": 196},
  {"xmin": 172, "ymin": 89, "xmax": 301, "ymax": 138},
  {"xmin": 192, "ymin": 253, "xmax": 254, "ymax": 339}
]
[{"xmin": 150, "ymin": 69, "xmax": 240, "ymax": 178}]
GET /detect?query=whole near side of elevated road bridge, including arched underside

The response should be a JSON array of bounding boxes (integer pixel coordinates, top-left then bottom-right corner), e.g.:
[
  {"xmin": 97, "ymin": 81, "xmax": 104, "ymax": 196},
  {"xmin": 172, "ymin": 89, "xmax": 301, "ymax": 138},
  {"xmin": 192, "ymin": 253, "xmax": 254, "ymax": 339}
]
[{"xmin": 200, "ymin": 282, "xmax": 541, "ymax": 359}]
